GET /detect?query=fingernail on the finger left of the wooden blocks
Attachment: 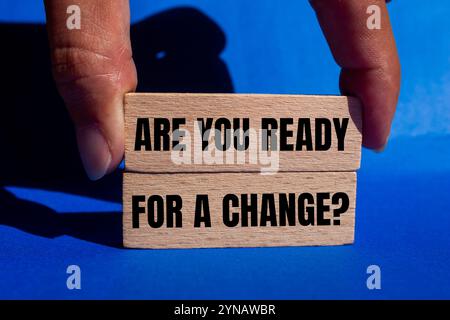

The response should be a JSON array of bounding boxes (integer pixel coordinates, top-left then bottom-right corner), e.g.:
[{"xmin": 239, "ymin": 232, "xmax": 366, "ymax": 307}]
[{"xmin": 77, "ymin": 125, "xmax": 111, "ymax": 180}]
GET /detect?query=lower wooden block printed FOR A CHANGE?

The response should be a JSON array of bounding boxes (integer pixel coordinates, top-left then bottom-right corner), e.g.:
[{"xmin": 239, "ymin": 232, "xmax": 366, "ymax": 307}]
[{"xmin": 123, "ymin": 172, "xmax": 356, "ymax": 248}]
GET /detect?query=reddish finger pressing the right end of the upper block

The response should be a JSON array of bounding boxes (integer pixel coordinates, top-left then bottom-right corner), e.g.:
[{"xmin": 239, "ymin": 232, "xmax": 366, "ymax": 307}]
[{"xmin": 310, "ymin": 0, "xmax": 400, "ymax": 150}]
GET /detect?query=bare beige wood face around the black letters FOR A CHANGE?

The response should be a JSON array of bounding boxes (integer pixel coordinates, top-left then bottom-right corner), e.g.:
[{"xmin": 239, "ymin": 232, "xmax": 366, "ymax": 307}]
[{"xmin": 123, "ymin": 172, "xmax": 356, "ymax": 248}]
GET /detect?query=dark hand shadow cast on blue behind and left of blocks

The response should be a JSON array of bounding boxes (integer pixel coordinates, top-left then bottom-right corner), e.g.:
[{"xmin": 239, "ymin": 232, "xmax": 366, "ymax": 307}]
[{"xmin": 0, "ymin": 7, "xmax": 233, "ymax": 246}]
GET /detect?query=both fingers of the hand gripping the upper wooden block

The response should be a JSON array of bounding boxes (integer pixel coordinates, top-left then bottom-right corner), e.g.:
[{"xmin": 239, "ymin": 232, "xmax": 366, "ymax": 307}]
[{"xmin": 45, "ymin": 0, "xmax": 400, "ymax": 180}]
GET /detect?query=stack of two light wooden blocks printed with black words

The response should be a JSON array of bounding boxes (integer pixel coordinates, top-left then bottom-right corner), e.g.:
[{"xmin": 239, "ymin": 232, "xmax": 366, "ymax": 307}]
[{"xmin": 123, "ymin": 93, "xmax": 361, "ymax": 248}]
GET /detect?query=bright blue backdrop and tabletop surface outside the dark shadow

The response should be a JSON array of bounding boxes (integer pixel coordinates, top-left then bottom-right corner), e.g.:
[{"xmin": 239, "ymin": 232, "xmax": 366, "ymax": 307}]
[{"xmin": 0, "ymin": 0, "xmax": 450, "ymax": 299}]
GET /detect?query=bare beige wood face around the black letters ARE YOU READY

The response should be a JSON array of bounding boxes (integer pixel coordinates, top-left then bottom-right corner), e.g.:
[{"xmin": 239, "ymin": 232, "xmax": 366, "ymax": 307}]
[{"xmin": 125, "ymin": 93, "xmax": 361, "ymax": 173}]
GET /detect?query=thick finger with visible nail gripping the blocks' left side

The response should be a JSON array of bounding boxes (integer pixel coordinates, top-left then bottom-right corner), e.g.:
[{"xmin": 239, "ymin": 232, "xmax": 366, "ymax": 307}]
[{"xmin": 45, "ymin": 0, "xmax": 137, "ymax": 180}]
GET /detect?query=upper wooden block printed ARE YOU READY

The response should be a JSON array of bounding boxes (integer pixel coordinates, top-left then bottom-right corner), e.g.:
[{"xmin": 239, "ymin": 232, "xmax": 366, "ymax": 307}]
[{"xmin": 125, "ymin": 93, "xmax": 361, "ymax": 173}]
